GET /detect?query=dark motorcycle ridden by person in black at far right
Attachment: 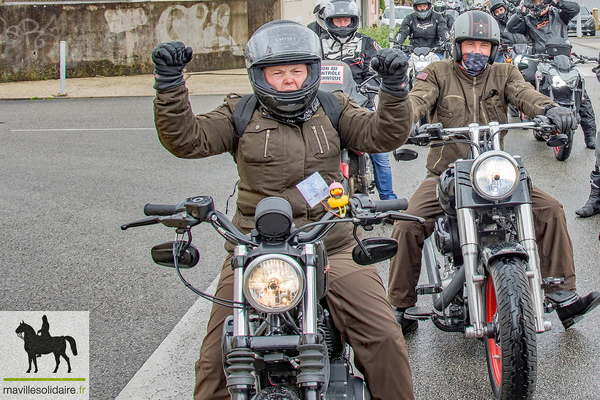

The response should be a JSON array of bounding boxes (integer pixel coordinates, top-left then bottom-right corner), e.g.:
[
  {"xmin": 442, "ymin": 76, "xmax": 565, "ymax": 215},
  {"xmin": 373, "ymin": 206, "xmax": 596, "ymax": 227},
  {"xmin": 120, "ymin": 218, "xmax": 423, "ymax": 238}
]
[{"xmin": 517, "ymin": 39, "xmax": 598, "ymax": 161}]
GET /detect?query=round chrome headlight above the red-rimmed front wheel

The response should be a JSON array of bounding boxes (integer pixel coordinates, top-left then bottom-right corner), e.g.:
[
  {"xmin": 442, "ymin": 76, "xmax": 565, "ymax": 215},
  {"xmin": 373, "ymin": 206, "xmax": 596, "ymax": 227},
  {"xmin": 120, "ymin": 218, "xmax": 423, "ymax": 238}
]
[{"xmin": 471, "ymin": 151, "xmax": 519, "ymax": 200}]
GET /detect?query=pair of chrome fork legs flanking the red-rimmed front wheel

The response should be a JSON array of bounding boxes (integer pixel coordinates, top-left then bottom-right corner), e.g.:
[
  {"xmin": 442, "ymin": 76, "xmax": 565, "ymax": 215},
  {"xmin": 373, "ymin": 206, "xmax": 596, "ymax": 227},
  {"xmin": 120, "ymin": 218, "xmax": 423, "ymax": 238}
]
[{"xmin": 458, "ymin": 204, "xmax": 551, "ymax": 338}]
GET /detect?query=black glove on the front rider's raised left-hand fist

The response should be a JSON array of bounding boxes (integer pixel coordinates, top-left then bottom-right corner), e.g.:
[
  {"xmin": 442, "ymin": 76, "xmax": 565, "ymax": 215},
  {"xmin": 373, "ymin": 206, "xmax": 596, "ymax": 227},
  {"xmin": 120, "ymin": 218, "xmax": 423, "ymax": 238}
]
[{"xmin": 152, "ymin": 42, "xmax": 193, "ymax": 90}]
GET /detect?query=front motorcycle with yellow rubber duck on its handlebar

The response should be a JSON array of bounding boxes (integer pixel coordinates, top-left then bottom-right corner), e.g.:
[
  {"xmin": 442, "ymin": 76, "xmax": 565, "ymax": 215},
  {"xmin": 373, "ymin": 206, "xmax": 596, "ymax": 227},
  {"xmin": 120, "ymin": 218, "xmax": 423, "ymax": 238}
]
[{"xmin": 121, "ymin": 188, "xmax": 416, "ymax": 400}]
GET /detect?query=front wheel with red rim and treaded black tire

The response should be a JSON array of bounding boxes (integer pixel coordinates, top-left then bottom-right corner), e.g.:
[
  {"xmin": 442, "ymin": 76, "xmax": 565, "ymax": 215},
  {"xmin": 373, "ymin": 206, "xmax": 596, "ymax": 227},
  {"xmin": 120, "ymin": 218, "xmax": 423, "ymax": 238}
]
[{"xmin": 484, "ymin": 256, "xmax": 537, "ymax": 400}]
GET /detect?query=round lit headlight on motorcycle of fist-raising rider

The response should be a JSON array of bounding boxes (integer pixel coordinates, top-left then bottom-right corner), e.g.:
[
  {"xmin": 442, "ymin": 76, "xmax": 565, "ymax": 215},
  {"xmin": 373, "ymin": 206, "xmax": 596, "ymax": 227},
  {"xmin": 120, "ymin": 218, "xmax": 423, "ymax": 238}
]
[{"xmin": 244, "ymin": 254, "xmax": 305, "ymax": 313}]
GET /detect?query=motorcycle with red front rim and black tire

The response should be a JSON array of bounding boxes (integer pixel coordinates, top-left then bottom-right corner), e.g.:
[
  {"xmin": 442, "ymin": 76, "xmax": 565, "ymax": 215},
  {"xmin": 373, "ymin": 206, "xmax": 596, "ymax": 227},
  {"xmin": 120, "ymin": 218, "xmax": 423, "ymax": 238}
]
[{"xmin": 397, "ymin": 119, "xmax": 567, "ymax": 399}]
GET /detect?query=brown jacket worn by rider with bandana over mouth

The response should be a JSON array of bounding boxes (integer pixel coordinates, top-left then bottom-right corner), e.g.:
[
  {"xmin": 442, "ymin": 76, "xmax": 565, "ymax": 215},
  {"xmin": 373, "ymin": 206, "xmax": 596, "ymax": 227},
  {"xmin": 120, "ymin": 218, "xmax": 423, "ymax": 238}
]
[{"xmin": 410, "ymin": 60, "xmax": 552, "ymax": 175}]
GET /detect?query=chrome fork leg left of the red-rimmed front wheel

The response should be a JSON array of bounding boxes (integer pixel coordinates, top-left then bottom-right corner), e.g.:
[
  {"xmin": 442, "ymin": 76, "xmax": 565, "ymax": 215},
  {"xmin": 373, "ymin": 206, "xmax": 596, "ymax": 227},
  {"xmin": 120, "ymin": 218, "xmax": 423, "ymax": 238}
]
[{"xmin": 458, "ymin": 208, "xmax": 485, "ymax": 338}]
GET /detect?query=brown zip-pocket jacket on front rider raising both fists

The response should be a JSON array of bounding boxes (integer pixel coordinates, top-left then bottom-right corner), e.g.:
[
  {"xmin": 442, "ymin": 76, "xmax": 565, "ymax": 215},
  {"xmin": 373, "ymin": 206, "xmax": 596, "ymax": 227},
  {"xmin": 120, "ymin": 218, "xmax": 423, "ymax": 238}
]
[{"xmin": 154, "ymin": 86, "xmax": 412, "ymax": 252}]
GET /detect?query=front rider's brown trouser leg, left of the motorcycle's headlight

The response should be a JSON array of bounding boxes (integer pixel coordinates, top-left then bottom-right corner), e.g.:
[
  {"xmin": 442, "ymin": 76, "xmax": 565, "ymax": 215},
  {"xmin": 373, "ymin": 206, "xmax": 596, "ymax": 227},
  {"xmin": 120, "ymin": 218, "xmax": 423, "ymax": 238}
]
[{"xmin": 194, "ymin": 256, "xmax": 233, "ymax": 400}]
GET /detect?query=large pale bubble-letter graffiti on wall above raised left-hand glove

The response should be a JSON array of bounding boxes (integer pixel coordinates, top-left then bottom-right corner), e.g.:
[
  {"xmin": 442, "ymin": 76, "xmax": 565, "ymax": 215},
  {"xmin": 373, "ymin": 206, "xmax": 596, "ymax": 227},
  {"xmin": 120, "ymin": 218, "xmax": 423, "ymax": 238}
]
[{"xmin": 156, "ymin": 3, "xmax": 244, "ymax": 56}]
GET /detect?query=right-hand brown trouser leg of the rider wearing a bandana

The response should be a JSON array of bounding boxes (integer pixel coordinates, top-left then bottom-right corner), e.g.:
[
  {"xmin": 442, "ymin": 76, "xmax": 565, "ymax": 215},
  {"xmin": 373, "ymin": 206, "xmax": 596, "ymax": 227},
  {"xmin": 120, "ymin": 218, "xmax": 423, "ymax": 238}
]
[{"xmin": 531, "ymin": 186, "xmax": 575, "ymax": 293}]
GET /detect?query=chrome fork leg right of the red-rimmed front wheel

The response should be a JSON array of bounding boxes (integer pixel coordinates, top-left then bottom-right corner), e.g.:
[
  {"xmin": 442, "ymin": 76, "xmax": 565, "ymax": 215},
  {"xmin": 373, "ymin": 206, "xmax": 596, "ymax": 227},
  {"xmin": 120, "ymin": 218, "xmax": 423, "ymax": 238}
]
[{"xmin": 516, "ymin": 204, "xmax": 550, "ymax": 333}]
